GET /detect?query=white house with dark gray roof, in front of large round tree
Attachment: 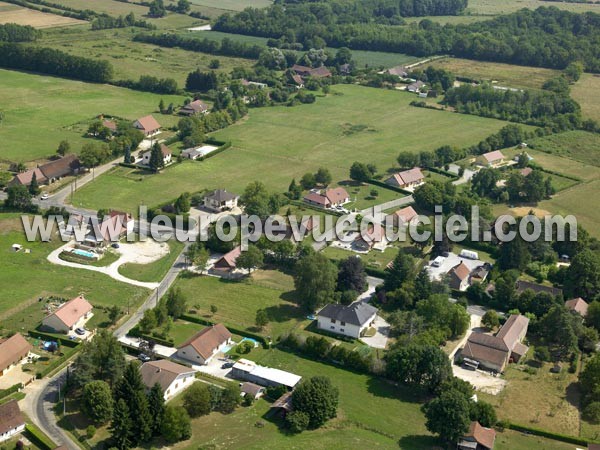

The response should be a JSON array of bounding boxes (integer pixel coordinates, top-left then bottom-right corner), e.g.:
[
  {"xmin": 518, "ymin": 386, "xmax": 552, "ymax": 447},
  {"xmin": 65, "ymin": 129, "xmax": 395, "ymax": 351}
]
[{"xmin": 317, "ymin": 302, "xmax": 377, "ymax": 338}]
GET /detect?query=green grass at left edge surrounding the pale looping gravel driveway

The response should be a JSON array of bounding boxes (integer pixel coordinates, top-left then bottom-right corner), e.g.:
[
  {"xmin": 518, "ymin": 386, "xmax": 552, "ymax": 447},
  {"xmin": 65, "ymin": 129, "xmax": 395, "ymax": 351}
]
[{"xmin": 0, "ymin": 214, "xmax": 148, "ymax": 329}]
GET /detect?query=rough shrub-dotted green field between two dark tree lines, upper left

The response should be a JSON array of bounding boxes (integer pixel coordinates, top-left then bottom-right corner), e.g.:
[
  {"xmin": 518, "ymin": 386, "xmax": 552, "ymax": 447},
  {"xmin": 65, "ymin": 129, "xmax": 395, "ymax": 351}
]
[{"xmin": 40, "ymin": 27, "xmax": 254, "ymax": 87}]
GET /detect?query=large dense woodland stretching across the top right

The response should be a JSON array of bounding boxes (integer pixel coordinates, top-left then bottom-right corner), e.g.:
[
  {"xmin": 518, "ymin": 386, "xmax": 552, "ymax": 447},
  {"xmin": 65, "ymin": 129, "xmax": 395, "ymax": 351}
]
[{"xmin": 214, "ymin": 3, "xmax": 600, "ymax": 72}]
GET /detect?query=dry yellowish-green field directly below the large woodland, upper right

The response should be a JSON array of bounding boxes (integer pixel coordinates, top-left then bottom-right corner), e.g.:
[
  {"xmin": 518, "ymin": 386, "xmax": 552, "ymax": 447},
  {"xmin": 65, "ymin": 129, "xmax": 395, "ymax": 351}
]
[{"xmin": 420, "ymin": 57, "xmax": 560, "ymax": 89}]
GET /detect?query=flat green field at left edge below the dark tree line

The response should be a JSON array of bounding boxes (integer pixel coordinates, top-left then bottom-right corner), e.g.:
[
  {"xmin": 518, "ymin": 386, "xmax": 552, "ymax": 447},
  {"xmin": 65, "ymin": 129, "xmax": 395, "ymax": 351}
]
[{"xmin": 0, "ymin": 70, "xmax": 184, "ymax": 161}]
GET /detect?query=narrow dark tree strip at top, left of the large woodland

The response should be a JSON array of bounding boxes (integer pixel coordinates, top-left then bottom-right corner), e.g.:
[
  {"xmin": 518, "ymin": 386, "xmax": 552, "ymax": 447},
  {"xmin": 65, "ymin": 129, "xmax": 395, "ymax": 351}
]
[{"xmin": 133, "ymin": 33, "xmax": 264, "ymax": 59}]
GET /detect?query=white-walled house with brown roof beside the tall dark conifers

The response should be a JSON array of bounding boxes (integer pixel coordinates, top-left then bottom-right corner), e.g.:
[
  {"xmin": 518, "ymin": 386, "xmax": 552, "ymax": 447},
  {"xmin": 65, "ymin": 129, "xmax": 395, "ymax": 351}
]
[{"xmin": 140, "ymin": 359, "xmax": 196, "ymax": 401}]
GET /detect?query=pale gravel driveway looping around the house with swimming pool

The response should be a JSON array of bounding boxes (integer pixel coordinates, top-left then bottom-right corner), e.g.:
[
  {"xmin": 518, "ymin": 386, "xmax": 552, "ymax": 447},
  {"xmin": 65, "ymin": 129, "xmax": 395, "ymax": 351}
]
[{"xmin": 48, "ymin": 239, "xmax": 169, "ymax": 290}]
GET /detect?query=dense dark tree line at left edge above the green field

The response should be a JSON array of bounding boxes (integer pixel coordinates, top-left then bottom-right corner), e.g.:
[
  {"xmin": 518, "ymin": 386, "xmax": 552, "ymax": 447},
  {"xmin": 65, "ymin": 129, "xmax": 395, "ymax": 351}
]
[{"xmin": 0, "ymin": 42, "xmax": 113, "ymax": 83}]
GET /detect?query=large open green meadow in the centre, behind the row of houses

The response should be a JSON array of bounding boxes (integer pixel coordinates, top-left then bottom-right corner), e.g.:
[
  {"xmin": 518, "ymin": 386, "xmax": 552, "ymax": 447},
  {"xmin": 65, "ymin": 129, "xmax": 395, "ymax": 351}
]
[{"xmin": 74, "ymin": 85, "xmax": 506, "ymax": 210}]
